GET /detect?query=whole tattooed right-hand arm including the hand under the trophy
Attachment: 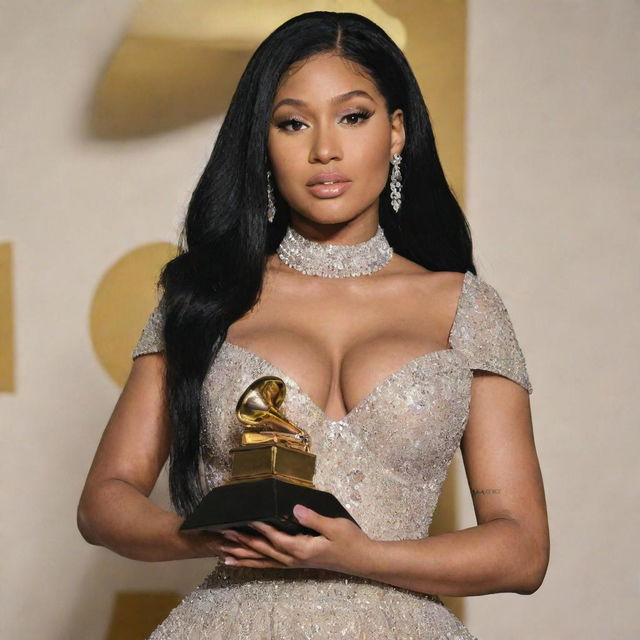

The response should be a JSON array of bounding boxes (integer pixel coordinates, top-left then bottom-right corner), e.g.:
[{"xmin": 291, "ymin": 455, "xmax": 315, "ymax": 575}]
[{"xmin": 222, "ymin": 372, "xmax": 549, "ymax": 596}]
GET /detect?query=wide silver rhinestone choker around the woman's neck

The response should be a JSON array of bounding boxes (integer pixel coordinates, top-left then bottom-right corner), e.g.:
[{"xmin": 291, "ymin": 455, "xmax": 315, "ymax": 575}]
[{"xmin": 276, "ymin": 225, "xmax": 393, "ymax": 278}]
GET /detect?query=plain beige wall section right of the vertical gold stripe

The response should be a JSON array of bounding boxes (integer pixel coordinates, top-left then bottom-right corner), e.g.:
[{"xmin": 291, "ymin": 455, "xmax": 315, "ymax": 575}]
[{"xmin": 461, "ymin": 0, "xmax": 640, "ymax": 640}]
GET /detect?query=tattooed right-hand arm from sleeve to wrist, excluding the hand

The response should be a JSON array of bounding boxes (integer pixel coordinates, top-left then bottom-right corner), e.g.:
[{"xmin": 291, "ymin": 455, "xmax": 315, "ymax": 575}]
[{"xmin": 361, "ymin": 372, "xmax": 549, "ymax": 596}]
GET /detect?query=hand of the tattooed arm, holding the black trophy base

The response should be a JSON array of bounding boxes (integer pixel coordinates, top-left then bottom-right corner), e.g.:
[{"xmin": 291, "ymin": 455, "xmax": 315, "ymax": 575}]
[{"xmin": 220, "ymin": 504, "xmax": 376, "ymax": 576}]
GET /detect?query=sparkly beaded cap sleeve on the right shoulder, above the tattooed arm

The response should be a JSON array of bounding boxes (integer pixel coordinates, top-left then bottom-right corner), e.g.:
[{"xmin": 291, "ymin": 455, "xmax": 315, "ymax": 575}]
[{"xmin": 450, "ymin": 271, "xmax": 533, "ymax": 393}]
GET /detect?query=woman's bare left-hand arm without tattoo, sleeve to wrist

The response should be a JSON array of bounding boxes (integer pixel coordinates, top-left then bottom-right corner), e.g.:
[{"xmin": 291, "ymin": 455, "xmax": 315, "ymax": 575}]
[{"xmin": 78, "ymin": 354, "xmax": 241, "ymax": 561}]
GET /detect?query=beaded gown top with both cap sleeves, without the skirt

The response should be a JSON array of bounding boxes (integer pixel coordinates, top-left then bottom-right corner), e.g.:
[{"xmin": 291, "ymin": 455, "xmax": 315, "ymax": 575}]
[{"xmin": 133, "ymin": 271, "xmax": 532, "ymax": 539}]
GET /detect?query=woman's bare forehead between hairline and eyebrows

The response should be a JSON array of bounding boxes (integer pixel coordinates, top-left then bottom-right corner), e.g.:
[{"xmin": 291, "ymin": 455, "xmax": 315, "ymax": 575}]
[{"xmin": 274, "ymin": 53, "xmax": 382, "ymax": 102}]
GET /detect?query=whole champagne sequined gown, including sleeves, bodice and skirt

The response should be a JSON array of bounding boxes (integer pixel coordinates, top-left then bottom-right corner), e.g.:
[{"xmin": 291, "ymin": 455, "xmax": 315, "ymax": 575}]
[{"xmin": 132, "ymin": 271, "xmax": 532, "ymax": 640}]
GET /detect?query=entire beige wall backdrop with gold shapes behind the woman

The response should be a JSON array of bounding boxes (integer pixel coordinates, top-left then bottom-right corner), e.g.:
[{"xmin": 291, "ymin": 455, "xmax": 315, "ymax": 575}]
[{"xmin": 0, "ymin": 0, "xmax": 640, "ymax": 640}]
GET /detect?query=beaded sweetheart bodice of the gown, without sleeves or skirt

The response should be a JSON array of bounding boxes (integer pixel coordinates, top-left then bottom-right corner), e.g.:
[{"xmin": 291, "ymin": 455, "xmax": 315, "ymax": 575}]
[{"xmin": 201, "ymin": 343, "xmax": 471, "ymax": 539}]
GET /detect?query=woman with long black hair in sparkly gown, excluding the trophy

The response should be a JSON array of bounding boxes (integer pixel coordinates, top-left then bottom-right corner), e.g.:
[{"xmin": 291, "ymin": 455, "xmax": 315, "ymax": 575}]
[{"xmin": 78, "ymin": 12, "xmax": 549, "ymax": 640}]
